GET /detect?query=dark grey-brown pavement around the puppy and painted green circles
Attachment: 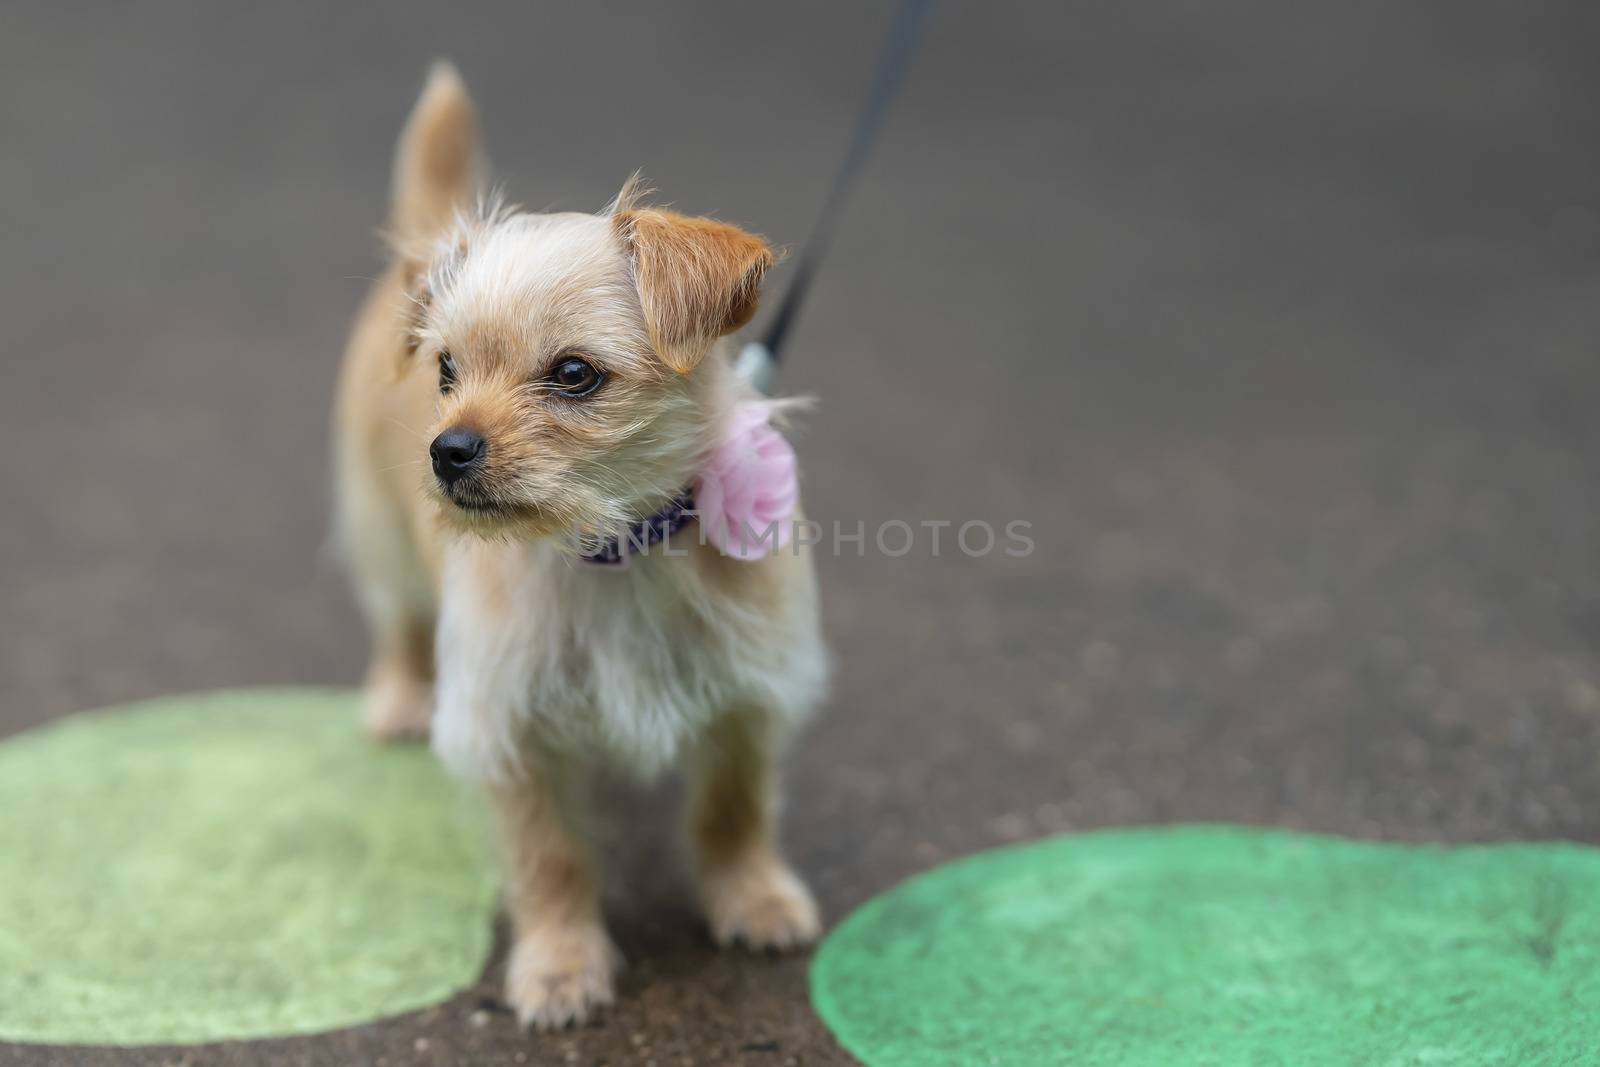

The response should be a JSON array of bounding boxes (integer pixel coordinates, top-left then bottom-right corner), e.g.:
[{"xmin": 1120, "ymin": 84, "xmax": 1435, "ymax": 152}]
[{"xmin": 0, "ymin": 0, "xmax": 1600, "ymax": 1067}]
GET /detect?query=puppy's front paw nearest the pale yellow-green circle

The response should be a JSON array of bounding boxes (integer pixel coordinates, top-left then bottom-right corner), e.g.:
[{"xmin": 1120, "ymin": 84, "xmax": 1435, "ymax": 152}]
[{"xmin": 506, "ymin": 926, "xmax": 618, "ymax": 1030}]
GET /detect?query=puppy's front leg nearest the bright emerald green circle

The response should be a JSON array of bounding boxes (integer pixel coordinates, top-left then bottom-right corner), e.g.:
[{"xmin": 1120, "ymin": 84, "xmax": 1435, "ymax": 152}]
[{"xmin": 690, "ymin": 710, "xmax": 822, "ymax": 949}]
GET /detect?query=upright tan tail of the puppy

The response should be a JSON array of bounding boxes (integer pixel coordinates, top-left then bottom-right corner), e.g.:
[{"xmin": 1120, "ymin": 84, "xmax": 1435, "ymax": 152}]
[{"xmin": 389, "ymin": 59, "xmax": 483, "ymax": 248}]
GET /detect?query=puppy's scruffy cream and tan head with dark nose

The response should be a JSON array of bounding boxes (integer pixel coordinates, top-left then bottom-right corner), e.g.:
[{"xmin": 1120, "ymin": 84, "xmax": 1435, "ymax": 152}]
[{"xmin": 410, "ymin": 182, "xmax": 773, "ymax": 537}]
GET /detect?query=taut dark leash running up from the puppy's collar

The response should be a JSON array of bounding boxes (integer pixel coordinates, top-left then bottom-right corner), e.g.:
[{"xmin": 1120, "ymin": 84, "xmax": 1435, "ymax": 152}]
[{"xmin": 739, "ymin": 0, "xmax": 933, "ymax": 392}]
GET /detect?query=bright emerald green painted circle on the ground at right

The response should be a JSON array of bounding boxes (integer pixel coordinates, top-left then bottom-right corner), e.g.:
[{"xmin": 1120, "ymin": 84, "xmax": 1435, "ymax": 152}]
[{"xmin": 811, "ymin": 827, "xmax": 1600, "ymax": 1067}]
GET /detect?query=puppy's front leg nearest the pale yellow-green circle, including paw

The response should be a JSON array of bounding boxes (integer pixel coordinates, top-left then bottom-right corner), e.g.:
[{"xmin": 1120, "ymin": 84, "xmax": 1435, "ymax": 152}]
[{"xmin": 490, "ymin": 760, "xmax": 616, "ymax": 1030}]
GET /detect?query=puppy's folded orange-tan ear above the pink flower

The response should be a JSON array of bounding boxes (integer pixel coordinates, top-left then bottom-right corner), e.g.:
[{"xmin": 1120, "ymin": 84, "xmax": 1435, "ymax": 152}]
[{"xmin": 611, "ymin": 206, "xmax": 773, "ymax": 374}]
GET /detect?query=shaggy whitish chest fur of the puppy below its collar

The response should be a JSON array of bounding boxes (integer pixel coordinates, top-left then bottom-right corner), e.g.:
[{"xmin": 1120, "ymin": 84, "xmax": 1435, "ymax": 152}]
[{"xmin": 434, "ymin": 528, "xmax": 827, "ymax": 779}]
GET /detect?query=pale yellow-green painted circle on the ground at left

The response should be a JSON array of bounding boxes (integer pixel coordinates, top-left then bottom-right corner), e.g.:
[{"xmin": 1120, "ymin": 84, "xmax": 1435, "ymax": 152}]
[{"xmin": 0, "ymin": 689, "xmax": 494, "ymax": 1045}]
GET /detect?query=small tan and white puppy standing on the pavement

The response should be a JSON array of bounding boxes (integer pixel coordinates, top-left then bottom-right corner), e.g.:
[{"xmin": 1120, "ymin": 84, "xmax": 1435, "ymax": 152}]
[{"xmin": 326, "ymin": 66, "xmax": 826, "ymax": 1027}]
